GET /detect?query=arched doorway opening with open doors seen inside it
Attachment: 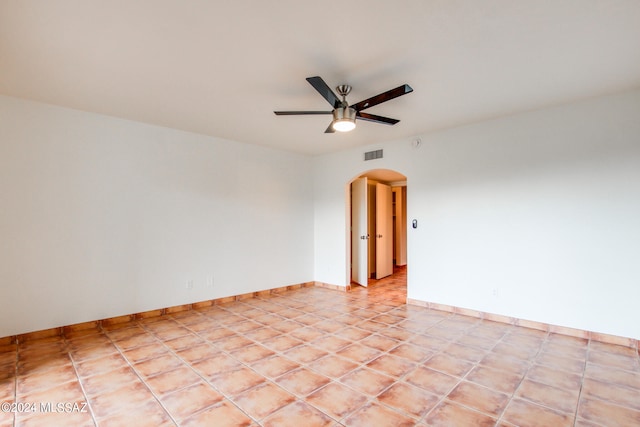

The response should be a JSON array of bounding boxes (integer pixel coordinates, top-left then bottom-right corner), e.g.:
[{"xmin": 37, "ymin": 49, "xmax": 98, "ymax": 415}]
[{"xmin": 347, "ymin": 169, "xmax": 407, "ymax": 287}]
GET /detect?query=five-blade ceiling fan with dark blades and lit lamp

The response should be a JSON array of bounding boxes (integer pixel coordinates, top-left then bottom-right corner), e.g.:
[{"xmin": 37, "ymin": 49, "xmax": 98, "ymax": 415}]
[{"xmin": 274, "ymin": 76, "xmax": 413, "ymax": 133}]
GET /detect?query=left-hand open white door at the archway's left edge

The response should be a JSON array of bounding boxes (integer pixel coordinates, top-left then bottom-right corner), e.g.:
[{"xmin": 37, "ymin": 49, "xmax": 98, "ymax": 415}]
[{"xmin": 351, "ymin": 178, "xmax": 369, "ymax": 286}]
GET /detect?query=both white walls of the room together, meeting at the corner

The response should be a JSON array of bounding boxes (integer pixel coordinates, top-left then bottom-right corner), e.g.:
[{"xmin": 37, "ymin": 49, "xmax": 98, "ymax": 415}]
[{"xmin": 0, "ymin": 91, "xmax": 640, "ymax": 338}]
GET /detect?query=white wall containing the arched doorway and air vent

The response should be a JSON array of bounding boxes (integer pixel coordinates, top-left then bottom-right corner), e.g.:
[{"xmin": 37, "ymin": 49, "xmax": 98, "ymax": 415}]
[{"xmin": 314, "ymin": 91, "xmax": 640, "ymax": 338}]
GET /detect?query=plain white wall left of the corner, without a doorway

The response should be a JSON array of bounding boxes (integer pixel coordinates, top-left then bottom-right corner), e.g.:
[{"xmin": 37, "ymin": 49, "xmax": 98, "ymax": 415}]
[{"xmin": 0, "ymin": 97, "xmax": 313, "ymax": 337}]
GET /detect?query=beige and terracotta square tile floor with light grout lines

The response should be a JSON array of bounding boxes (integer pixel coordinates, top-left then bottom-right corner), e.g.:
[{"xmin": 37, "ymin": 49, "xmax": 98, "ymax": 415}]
[{"xmin": 0, "ymin": 269, "xmax": 640, "ymax": 427}]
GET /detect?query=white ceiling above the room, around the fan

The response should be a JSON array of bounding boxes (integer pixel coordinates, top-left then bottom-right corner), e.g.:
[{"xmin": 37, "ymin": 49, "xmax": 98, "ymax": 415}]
[{"xmin": 0, "ymin": 0, "xmax": 640, "ymax": 154}]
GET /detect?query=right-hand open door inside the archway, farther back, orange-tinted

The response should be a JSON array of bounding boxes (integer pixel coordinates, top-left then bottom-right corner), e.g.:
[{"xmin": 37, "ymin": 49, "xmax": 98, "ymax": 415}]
[{"xmin": 376, "ymin": 183, "xmax": 393, "ymax": 279}]
